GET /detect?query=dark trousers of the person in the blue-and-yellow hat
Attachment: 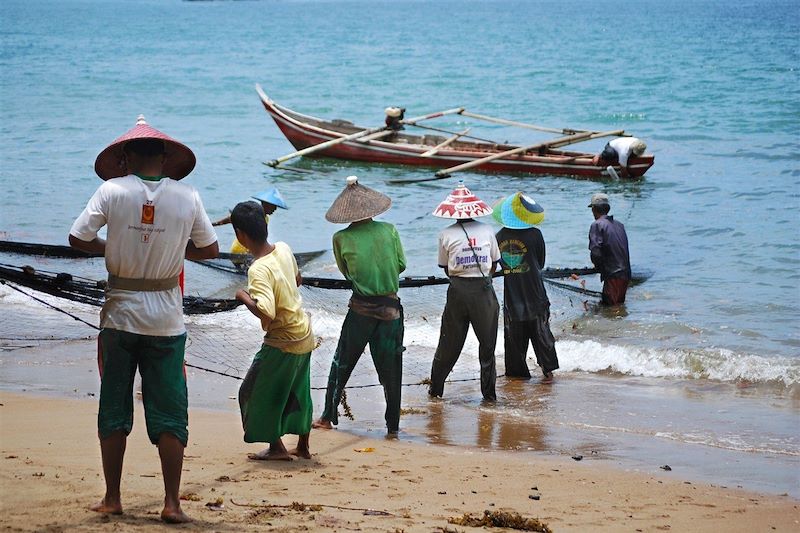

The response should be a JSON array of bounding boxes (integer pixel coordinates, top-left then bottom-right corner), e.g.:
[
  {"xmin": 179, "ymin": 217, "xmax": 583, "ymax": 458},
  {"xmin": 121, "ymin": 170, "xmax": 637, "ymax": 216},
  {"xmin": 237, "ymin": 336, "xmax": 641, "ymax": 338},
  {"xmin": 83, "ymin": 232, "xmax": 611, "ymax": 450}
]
[{"xmin": 503, "ymin": 309, "xmax": 558, "ymax": 378}]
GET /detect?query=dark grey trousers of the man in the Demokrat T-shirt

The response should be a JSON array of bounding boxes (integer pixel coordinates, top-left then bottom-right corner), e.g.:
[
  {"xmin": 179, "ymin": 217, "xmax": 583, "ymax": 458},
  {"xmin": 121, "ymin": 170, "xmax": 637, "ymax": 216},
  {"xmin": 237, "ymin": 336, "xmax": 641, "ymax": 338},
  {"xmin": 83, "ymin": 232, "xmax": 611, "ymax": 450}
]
[{"xmin": 428, "ymin": 277, "xmax": 500, "ymax": 400}]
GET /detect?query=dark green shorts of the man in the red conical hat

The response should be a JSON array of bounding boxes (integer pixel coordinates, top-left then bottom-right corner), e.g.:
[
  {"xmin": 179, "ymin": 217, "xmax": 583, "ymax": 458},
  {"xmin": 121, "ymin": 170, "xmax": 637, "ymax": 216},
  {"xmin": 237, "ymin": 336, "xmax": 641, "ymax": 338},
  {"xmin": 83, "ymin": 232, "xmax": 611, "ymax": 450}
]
[{"xmin": 97, "ymin": 329, "xmax": 189, "ymax": 446}]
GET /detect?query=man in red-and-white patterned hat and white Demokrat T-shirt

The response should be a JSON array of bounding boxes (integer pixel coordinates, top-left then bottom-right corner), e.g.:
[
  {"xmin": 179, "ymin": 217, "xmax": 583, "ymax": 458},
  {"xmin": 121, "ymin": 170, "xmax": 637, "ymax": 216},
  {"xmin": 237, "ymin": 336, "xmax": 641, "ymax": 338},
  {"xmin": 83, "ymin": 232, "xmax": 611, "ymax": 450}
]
[{"xmin": 428, "ymin": 181, "xmax": 500, "ymax": 401}]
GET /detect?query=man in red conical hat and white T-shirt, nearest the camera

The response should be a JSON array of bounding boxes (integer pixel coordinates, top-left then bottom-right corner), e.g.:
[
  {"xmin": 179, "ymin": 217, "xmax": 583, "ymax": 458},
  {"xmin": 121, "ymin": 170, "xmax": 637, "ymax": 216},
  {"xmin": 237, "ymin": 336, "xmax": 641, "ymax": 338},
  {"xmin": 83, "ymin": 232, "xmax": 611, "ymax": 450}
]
[{"xmin": 69, "ymin": 115, "xmax": 219, "ymax": 523}]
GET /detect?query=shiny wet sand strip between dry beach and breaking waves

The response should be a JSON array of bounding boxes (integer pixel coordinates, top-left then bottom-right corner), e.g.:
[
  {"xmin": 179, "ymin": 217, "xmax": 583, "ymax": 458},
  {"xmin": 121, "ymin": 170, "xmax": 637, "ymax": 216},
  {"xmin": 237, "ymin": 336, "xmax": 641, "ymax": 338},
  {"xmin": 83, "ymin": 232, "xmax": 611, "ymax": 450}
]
[{"xmin": 0, "ymin": 332, "xmax": 800, "ymax": 498}]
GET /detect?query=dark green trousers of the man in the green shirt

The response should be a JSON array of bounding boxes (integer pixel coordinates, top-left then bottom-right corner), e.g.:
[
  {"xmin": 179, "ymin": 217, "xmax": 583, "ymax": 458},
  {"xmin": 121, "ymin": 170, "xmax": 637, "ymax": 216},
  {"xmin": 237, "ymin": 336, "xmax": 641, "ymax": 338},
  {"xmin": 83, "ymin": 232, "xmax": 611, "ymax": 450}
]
[{"xmin": 322, "ymin": 308, "xmax": 404, "ymax": 432}]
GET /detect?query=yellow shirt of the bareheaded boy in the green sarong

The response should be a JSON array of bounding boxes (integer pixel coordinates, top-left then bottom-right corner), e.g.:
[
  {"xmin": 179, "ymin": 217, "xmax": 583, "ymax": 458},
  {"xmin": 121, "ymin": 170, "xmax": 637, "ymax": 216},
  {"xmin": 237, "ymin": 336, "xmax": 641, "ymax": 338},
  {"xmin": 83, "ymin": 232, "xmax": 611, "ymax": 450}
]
[{"xmin": 247, "ymin": 242, "xmax": 315, "ymax": 354}]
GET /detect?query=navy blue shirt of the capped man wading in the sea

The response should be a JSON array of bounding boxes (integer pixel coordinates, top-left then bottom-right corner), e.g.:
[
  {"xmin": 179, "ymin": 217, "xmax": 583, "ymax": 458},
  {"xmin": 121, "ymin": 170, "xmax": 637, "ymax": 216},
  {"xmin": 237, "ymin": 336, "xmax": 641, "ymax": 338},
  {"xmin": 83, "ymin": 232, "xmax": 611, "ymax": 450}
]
[{"xmin": 589, "ymin": 215, "xmax": 631, "ymax": 281}]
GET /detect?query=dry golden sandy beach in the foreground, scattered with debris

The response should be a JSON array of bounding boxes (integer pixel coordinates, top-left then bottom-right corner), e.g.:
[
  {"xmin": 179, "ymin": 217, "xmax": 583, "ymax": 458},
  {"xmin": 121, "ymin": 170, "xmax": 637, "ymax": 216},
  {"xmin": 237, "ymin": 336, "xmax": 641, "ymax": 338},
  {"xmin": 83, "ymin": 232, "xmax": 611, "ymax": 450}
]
[{"xmin": 0, "ymin": 392, "xmax": 800, "ymax": 531}]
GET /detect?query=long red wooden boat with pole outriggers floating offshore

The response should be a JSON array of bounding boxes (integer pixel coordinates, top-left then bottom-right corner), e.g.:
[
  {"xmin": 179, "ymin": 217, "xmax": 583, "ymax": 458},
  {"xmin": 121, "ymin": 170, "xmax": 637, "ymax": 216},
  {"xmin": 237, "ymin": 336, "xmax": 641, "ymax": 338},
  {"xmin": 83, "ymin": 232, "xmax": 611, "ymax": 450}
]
[{"xmin": 256, "ymin": 85, "xmax": 654, "ymax": 181}]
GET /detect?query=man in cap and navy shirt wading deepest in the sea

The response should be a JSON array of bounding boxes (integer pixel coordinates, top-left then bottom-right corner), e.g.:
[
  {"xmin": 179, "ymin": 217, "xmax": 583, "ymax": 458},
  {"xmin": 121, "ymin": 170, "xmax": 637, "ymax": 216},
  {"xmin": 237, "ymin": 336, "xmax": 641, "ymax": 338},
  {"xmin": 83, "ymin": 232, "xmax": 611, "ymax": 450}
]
[{"xmin": 589, "ymin": 192, "xmax": 631, "ymax": 305}]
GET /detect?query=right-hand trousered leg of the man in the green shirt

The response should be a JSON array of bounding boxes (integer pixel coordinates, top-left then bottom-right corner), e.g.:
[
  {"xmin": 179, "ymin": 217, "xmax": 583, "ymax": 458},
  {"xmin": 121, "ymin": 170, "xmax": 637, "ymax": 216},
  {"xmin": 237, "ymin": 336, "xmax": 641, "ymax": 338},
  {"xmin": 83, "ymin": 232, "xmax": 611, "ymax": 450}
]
[{"xmin": 369, "ymin": 310, "xmax": 405, "ymax": 433}]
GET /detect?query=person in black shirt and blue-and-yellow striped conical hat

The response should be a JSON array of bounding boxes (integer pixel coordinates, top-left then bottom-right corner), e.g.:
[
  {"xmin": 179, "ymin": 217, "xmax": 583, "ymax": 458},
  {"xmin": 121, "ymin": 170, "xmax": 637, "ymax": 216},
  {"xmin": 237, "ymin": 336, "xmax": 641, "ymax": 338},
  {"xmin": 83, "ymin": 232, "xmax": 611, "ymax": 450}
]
[{"xmin": 492, "ymin": 192, "xmax": 558, "ymax": 383}]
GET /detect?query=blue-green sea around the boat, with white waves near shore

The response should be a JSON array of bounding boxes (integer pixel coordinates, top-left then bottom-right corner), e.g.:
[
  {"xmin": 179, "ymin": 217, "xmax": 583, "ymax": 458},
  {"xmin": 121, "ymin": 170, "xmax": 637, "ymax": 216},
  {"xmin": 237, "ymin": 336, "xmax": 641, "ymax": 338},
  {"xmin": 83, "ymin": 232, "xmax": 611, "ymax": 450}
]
[{"xmin": 0, "ymin": 0, "xmax": 800, "ymax": 488}]
